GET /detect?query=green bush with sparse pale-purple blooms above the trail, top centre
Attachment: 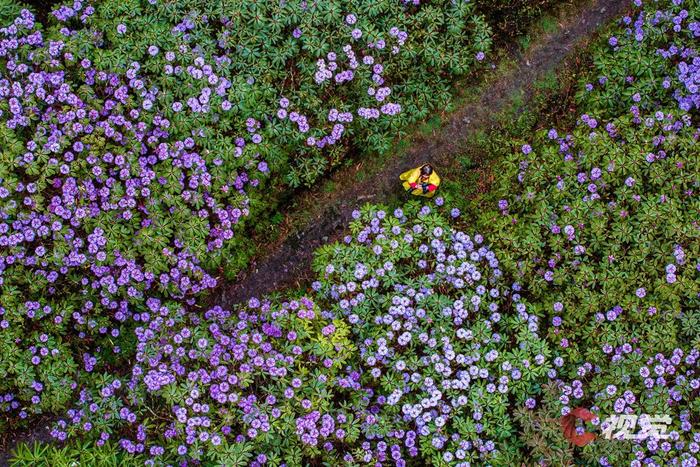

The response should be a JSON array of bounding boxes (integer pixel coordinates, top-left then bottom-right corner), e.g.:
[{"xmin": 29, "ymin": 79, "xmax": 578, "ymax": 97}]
[{"xmin": 64, "ymin": 0, "xmax": 491, "ymax": 187}]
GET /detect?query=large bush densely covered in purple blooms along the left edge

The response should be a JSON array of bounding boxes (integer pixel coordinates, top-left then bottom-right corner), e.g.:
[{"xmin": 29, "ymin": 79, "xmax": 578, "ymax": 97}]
[{"xmin": 0, "ymin": 10, "xmax": 259, "ymax": 411}]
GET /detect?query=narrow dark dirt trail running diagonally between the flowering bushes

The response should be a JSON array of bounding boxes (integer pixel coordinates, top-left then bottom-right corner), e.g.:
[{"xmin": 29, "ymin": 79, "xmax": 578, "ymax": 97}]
[{"xmin": 210, "ymin": 0, "xmax": 628, "ymax": 307}]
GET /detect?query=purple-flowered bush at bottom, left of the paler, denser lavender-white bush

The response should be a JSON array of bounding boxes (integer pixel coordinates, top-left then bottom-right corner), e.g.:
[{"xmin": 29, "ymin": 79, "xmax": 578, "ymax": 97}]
[{"xmin": 52, "ymin": 298, "xmax": 361, "ymax": 464}]
